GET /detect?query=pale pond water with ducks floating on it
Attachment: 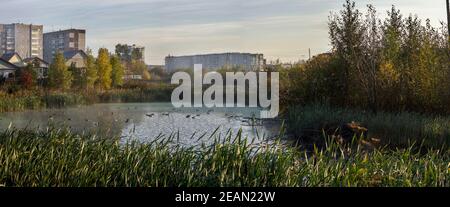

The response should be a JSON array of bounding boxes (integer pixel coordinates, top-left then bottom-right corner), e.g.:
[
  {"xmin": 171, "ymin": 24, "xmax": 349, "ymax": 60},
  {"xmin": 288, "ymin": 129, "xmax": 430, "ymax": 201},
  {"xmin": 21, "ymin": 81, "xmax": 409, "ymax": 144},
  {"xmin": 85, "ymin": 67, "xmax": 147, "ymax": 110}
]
[{"xmin": 0, "ymin": 103, "xmax": 281, "ymax": 145}]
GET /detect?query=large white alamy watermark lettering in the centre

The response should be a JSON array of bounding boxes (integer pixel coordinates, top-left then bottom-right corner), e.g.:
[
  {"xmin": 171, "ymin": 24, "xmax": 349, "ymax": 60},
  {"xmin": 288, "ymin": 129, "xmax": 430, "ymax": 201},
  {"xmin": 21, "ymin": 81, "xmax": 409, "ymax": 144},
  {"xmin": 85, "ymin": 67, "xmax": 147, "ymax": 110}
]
[{"xmin": 171, "ymin": 64, "xmax": 280, "ymax": 119}]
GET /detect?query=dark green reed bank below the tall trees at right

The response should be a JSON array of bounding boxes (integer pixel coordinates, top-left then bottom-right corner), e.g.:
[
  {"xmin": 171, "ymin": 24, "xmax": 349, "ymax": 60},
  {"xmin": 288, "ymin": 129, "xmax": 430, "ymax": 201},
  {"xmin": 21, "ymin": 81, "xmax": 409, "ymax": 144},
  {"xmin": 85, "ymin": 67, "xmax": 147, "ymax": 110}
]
[{"xmin": 286, "ymin": 104, "xmax": 450, "ymax": 149}]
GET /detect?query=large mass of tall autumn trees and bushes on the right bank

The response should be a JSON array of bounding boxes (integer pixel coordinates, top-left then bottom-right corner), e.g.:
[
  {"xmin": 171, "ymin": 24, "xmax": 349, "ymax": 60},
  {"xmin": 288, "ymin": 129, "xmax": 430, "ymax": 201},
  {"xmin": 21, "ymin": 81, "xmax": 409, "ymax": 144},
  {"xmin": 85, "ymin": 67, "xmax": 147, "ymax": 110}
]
[{"xmin": 281, "ymin": 0, "xmax": 450, "ymax": 113}]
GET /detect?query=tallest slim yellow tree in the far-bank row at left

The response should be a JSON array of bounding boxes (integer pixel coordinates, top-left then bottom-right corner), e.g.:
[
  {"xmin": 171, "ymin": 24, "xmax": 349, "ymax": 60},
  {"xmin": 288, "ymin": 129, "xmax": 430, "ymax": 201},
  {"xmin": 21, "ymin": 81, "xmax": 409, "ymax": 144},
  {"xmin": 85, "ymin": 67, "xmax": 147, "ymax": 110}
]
[{"xmin": 96, "ymin": 48, "xmax": 112, "ymax": 90}]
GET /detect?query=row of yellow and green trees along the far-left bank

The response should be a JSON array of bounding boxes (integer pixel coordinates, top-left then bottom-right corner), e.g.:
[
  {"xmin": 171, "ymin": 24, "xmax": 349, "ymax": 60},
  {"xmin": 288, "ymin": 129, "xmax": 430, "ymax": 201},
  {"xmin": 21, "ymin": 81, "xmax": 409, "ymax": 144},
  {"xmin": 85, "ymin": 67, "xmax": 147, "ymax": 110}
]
[{"xmin": 0, "ymin": 48, "xmax": 155, "ymax": 93}]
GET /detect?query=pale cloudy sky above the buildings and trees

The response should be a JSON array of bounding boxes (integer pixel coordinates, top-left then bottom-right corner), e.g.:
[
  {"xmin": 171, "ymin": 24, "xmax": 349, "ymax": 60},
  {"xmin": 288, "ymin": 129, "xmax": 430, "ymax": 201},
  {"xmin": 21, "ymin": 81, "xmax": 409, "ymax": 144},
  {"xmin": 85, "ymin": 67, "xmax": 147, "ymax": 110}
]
[{"xmin": 0, "ymin": 0, "xmax": 447, "ymax": 65}]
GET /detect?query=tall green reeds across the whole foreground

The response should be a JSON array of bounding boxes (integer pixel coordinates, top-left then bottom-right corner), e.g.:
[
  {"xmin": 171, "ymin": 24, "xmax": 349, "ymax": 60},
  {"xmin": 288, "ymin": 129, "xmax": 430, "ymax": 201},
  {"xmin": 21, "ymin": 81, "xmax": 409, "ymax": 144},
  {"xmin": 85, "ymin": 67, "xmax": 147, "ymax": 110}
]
[{"xmin": 0, "ymin": 130, "xmax": 450, "ymax": 187}]
